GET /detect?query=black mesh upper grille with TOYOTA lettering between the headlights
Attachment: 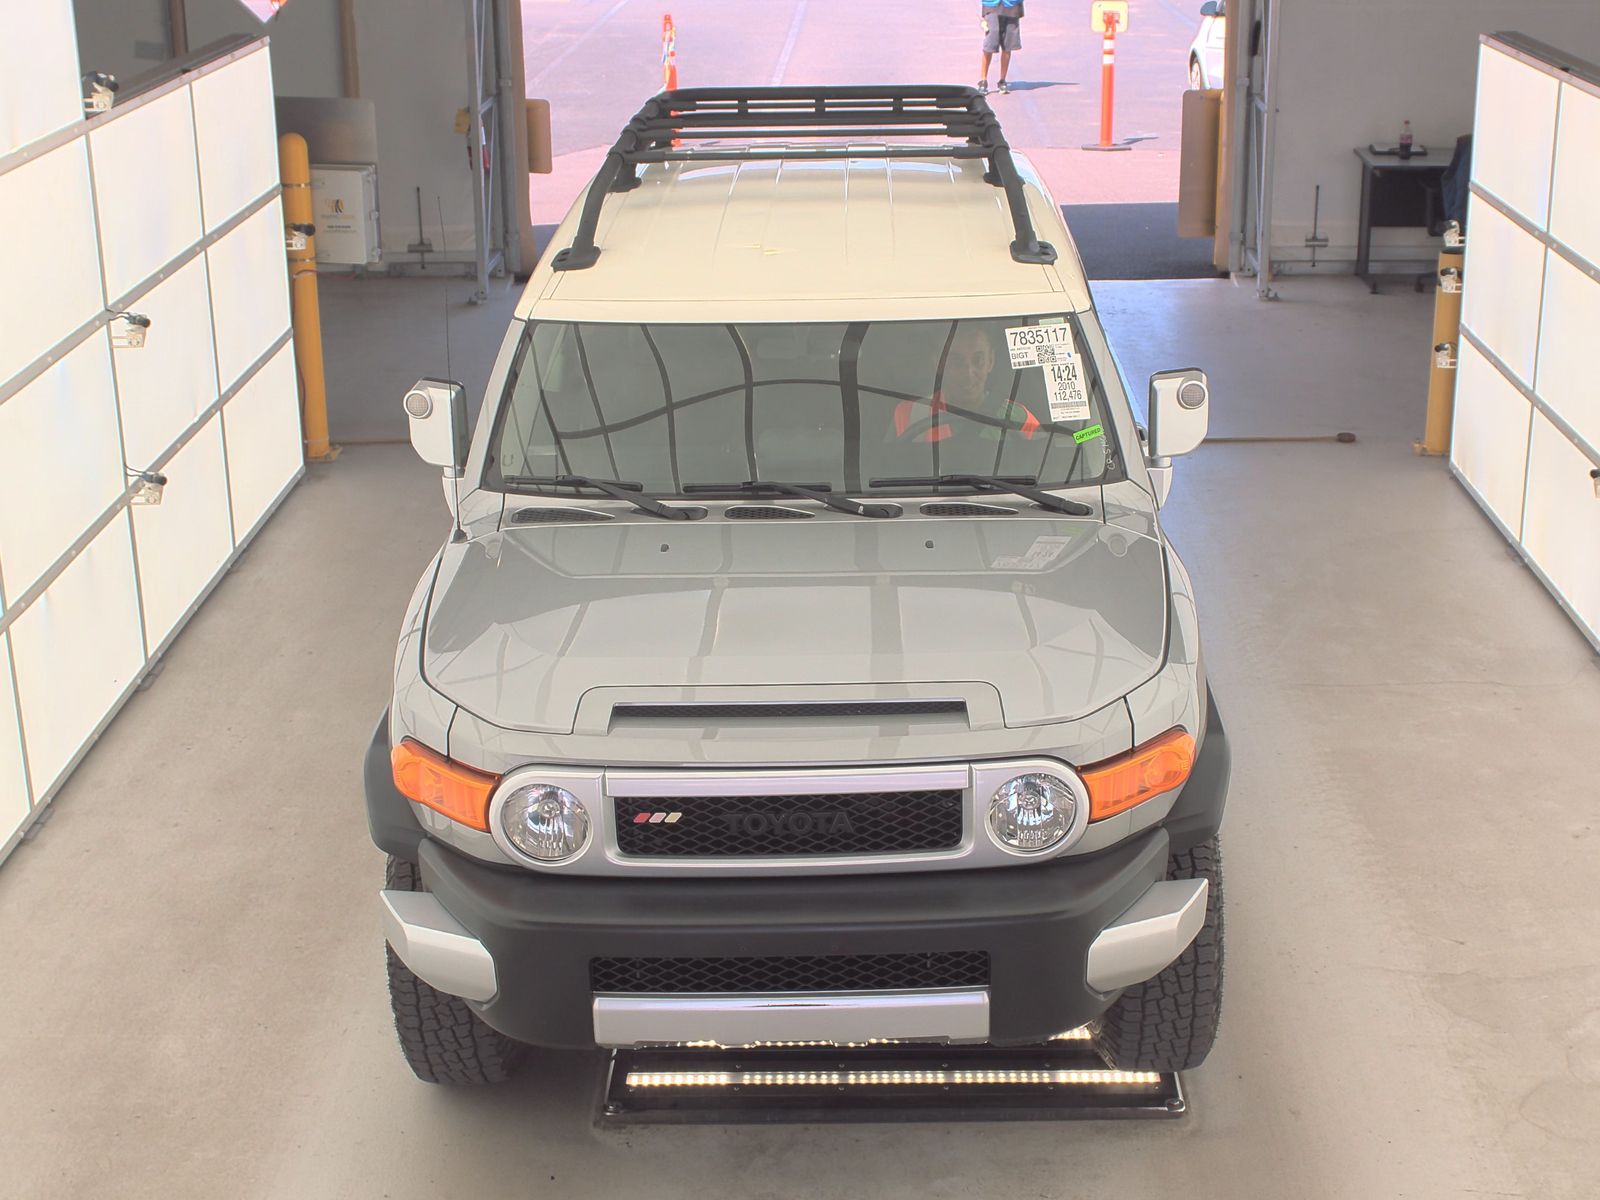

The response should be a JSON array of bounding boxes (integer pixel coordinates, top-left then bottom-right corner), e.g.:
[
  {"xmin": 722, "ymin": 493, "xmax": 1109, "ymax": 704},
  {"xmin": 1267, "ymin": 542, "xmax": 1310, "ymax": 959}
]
[{"xmin": 614, "ymin": 790, "xmax": 965, "ymax": 858}]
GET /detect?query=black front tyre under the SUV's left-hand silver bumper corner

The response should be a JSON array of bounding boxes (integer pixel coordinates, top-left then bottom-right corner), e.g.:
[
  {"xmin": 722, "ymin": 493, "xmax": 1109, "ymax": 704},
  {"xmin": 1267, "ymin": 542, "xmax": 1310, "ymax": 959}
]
[{"xmin": 384, "ymin": 854, "xmax": 526, "ymax": 1085}]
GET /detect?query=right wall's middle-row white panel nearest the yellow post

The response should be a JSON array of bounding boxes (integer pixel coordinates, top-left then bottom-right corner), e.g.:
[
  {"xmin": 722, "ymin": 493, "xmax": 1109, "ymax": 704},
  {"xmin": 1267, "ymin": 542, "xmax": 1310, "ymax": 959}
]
[{"xmin": 1461, "ymin": 197, "xmax": 1544, "ymax": 386}]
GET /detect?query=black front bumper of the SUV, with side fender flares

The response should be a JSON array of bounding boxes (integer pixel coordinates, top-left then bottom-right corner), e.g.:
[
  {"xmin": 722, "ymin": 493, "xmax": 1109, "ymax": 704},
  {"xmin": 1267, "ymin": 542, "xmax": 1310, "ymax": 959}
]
[{"xmin": 366, "ymin": 704, "xmax": 1229, "ymax": 1046}]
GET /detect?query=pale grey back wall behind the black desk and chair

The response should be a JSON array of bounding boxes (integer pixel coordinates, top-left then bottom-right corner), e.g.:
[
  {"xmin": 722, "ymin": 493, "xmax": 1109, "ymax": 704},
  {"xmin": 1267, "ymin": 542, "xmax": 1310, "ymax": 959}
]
[{"xmin": 1260, "ymin": 0, "xmax": 1600, "ymax": 269}]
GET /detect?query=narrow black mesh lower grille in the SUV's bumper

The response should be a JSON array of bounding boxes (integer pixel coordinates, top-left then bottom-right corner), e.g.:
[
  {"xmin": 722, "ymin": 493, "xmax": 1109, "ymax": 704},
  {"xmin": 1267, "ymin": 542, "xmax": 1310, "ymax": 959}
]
[{"xmin": 589, "ymin": 950, "xmax": 989, "ymax": 995}]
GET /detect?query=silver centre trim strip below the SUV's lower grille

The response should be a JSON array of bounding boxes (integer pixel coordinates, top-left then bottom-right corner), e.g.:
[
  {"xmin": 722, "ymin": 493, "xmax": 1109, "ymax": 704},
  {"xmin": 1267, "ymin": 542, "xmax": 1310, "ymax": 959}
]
[{"xmin": 594, "ymin": 989, "xmax": 989, "ymax": 1046}]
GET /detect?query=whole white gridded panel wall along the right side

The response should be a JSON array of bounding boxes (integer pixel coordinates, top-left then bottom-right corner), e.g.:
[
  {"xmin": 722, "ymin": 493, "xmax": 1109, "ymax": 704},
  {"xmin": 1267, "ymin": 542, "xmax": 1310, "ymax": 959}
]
[{"xmin": 1451, "ymin": 35, "xmax": 1600, "ymax": 659}]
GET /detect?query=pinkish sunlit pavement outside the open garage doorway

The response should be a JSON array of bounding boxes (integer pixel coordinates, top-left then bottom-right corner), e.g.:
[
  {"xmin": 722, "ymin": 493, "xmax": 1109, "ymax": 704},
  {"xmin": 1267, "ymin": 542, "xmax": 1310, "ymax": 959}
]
[{"xmin": 523, "ymin": 0, "xmax": 1200, "ymax": 224}]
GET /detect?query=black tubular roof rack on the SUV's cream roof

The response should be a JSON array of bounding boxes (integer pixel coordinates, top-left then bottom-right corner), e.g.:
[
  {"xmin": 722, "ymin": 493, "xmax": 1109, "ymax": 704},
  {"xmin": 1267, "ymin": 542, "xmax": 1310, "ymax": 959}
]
[{"xmin": 550, "ymin": 83, "xmax": 1056, "ymax": 270}]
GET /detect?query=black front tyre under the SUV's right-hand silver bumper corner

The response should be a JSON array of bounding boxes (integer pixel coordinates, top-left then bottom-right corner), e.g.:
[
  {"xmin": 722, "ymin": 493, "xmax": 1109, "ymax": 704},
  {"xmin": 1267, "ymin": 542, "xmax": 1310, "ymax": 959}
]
[{"xmin": 1093, "ymin": 838, "xmax": 1222, "ymax": 1070}]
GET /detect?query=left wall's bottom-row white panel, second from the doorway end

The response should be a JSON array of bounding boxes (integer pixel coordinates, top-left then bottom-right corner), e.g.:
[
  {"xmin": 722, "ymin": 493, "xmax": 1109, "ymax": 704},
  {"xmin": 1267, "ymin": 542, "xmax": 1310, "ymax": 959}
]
[{"xmin": 133, "ymin": 413, "xmax": 234, "ymax": 651}]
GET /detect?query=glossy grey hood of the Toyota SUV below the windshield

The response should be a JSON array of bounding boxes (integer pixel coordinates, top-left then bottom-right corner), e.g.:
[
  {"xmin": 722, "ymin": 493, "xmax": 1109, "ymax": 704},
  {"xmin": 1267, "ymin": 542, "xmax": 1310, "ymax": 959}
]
[{"xmin": 422, "ymin": 515, "xmax": 1168, "ymax": 733}]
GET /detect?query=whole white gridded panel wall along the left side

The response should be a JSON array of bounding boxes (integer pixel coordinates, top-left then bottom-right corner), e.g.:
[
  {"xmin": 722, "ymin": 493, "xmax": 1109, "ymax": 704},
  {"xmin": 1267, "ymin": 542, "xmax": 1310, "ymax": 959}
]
[{"xmin": 0, "ymin": 14, "xmax": 302, "ymax": 858}]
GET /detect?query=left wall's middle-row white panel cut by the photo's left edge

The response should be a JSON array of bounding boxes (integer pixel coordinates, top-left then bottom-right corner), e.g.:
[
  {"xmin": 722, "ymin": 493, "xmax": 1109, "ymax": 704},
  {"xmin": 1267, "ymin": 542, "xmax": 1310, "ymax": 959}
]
[{"xmin": 0, "ymin": 330, "xmax": 126, "ymax": 600}]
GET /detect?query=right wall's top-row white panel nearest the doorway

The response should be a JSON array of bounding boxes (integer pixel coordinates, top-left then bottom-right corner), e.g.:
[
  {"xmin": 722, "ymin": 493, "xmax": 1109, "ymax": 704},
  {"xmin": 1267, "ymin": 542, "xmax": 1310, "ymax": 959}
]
[{"xmin": 1467, "ymin": 46, "xmax": 1560, "ymax": 232}]
